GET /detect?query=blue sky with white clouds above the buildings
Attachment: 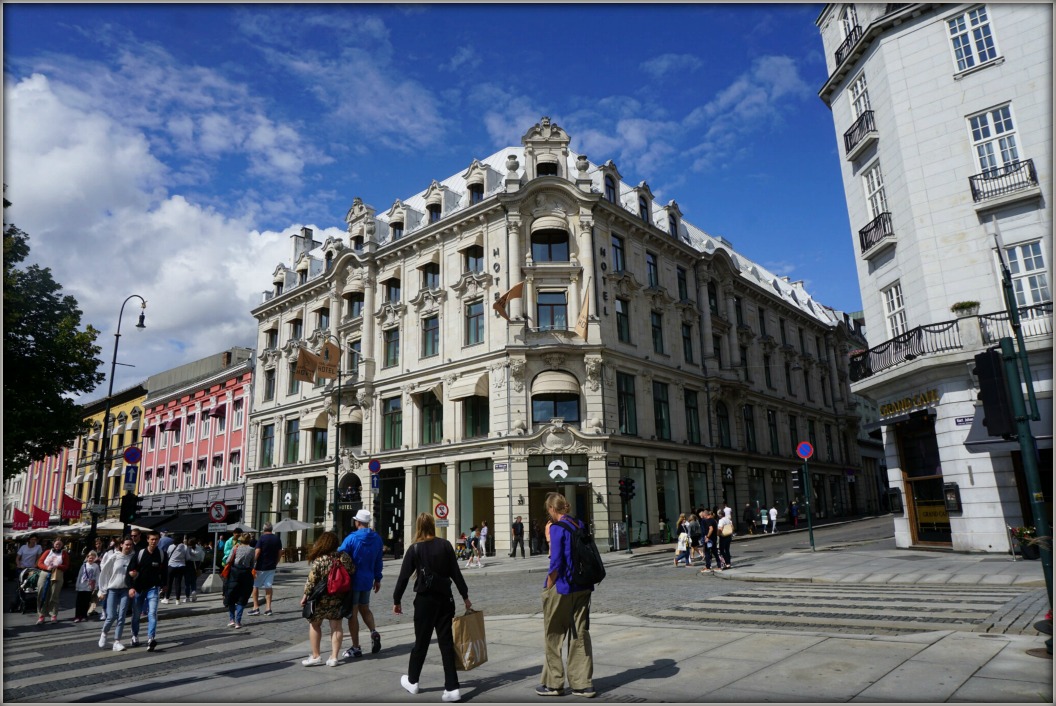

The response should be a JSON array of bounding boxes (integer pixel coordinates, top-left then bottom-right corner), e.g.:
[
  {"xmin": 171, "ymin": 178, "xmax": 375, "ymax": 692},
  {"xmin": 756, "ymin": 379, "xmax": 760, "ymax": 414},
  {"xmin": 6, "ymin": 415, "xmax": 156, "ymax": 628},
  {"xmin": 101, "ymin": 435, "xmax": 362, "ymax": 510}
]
[{"xmin": 3, "ymin": 4, "xmax": 861, "ymax": 396}]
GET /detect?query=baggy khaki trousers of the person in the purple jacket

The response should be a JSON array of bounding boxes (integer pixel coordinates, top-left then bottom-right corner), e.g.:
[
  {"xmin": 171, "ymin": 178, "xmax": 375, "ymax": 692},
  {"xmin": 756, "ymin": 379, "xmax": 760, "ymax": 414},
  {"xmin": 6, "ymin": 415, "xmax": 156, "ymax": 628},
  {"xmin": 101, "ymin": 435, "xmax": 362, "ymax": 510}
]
[{"xmin": 543, "ymin": 586, "xmax": 593, "ymax": 689}]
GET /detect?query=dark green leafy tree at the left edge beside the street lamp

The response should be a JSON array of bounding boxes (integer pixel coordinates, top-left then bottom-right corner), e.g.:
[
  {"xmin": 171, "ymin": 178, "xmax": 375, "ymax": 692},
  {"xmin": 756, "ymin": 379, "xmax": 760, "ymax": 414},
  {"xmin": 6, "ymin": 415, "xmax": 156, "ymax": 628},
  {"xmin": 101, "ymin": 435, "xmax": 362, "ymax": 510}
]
[{"xmin": 3, "ymin": 198, "xmax": 105, "ymax": 478}]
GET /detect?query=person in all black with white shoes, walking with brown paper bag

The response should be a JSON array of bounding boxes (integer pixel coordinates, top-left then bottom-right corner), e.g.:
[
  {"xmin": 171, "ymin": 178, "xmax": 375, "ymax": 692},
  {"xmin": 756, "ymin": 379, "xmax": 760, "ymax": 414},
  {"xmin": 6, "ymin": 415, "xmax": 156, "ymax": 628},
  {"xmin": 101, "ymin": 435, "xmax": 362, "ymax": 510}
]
[{"xmin": 393, "ymin": 513, "xmax": 470, "ymax": 702}]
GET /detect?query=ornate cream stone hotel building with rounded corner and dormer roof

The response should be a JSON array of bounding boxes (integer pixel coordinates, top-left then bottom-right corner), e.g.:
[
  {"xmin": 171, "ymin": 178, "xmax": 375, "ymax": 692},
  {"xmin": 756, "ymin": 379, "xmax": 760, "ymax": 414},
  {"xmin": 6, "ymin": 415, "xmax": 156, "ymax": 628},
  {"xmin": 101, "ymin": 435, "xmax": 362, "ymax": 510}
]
[{"xmin": 246, "ymin": 118, "xmax": 876, "ymax": 554}]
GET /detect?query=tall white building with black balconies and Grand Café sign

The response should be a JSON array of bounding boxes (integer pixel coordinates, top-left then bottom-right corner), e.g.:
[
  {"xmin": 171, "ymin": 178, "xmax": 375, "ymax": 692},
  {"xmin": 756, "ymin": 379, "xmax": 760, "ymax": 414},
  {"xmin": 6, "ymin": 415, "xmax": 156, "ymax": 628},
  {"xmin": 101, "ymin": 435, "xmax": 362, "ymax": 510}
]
[{"xmin": 817, "ymin": 3, "xmax": 1053, "ymax": 552}]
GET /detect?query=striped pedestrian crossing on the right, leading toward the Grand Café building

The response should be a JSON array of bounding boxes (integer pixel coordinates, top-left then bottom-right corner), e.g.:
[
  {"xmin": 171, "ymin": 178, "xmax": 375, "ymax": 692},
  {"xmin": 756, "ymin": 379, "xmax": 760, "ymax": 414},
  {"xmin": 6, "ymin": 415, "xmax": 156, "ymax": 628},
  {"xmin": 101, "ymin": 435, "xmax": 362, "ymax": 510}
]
[{"xmin": 650, "ymin": 584, "xmax": 1034, "ymax": 634}]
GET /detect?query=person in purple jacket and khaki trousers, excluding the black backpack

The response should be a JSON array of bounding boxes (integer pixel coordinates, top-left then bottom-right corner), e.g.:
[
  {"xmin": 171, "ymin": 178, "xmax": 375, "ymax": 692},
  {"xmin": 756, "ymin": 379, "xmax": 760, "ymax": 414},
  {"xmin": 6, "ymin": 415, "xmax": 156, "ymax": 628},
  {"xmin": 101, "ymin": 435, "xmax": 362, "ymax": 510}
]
[{"xmin": 535, "ymin": 493, "xmax": 596, "ymax": 699}]
